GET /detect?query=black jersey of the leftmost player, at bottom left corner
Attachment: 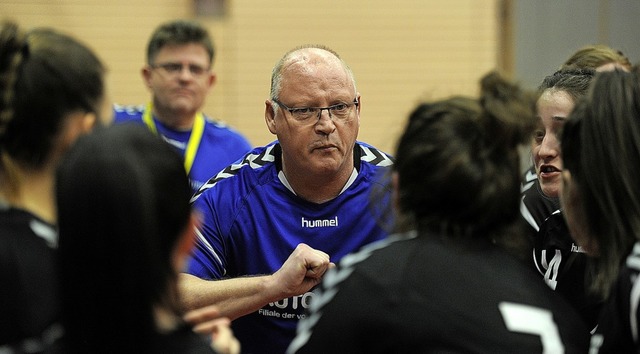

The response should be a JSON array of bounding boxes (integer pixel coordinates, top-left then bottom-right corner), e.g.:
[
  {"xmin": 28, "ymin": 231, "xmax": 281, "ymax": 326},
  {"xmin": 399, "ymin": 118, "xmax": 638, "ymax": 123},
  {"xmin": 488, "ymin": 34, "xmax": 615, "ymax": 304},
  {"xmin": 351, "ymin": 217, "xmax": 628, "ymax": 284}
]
[{"xmin": 0, "ymin": 205, "xmax": 60, "ymax": 352}]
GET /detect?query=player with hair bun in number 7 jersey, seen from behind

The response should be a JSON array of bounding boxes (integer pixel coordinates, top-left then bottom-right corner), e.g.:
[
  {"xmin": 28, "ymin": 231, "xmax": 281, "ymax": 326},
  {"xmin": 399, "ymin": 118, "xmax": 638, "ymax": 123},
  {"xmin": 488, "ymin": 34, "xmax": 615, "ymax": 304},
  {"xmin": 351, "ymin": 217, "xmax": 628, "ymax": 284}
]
[{"xmin": 288, "ymin": 73, "xmax": 589, "ymax": 353}]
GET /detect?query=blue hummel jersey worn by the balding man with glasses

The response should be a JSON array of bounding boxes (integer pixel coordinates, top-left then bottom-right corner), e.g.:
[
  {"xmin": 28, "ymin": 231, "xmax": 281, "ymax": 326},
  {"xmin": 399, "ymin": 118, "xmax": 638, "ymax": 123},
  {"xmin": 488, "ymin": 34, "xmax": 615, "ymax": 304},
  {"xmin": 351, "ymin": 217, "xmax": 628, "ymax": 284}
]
[{"xmin": 187, "ymin": 142, "xmax": 392, "ymax": 353}]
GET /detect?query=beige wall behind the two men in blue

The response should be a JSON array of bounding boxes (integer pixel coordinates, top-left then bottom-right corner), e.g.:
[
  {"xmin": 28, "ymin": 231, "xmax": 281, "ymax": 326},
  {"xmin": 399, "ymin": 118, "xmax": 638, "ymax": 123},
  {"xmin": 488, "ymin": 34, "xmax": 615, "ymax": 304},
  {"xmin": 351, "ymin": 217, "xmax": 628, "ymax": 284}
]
[{"xmin": 0, "ymin": 0, "xmax": 499, "ymax": 152}]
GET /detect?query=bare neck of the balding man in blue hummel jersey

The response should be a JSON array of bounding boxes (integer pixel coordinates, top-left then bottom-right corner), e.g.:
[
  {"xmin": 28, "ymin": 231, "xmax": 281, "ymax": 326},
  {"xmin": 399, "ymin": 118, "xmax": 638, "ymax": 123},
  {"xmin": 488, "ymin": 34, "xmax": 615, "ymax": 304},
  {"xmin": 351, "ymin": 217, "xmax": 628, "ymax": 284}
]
[{"xmin": 282, "ymin": 156, "xmax": 353, "ymax": 204}]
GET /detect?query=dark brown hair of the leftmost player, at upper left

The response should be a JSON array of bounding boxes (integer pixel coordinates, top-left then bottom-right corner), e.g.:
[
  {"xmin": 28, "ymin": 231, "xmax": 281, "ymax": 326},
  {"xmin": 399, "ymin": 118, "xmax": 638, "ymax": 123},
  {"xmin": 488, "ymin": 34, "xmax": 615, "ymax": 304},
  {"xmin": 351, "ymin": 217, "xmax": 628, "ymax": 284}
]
[{"xmin": 0, "ymin": 22, "xmax": 105, "ymax": 169}]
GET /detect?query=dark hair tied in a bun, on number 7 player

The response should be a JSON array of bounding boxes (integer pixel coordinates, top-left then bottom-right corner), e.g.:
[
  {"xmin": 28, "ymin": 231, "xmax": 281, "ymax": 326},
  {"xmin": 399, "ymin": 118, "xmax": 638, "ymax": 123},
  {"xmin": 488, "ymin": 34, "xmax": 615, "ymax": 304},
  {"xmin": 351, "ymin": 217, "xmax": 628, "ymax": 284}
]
[{"xmin": 394, "ymin": 72, "xmax": 536, "ymax": 252}]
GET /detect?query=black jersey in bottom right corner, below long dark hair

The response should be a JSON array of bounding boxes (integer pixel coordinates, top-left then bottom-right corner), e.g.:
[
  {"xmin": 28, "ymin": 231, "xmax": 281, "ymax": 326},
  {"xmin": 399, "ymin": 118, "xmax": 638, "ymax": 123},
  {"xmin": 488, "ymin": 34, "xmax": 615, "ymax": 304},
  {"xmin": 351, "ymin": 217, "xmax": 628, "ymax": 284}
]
[{"xmin": 590, "ymin": 242, "xmax": 640, "ymax": 353}]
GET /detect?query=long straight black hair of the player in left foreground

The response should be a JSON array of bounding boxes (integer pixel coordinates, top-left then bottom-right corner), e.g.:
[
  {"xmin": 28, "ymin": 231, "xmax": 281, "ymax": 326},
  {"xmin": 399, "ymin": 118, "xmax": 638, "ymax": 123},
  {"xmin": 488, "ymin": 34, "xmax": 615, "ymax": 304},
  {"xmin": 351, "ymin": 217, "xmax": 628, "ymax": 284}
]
[{"xmin": 56, "ymin": 124, "xmax": 191, "ymax": 353}]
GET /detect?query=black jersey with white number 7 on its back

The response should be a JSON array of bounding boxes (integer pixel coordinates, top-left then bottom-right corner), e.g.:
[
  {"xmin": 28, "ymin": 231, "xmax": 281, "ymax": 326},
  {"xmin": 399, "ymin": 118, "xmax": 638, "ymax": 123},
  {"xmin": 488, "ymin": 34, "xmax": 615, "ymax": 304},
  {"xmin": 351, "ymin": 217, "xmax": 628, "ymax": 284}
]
[{"xmin": 289, "ymin": 235, "xmax": 589, "ymax": 353}]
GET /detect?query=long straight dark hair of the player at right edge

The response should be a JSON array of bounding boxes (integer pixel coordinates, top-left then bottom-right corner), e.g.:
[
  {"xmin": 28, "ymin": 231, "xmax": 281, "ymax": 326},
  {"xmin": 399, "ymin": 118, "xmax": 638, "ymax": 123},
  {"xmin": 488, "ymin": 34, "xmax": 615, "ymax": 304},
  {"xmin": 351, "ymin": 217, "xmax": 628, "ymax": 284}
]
[{"xmin": 561, "ymin": 70, "xmax": 640, "ymax": 296}]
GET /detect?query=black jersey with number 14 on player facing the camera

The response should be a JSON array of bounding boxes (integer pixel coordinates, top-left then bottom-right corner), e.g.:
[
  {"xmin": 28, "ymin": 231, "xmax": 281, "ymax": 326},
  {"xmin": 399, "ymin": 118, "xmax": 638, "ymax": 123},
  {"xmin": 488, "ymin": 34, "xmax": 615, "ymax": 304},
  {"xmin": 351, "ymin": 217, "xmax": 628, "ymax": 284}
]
[{"xmin": 520, "ymin": 168, "xmax": 602, "ymax": 329}]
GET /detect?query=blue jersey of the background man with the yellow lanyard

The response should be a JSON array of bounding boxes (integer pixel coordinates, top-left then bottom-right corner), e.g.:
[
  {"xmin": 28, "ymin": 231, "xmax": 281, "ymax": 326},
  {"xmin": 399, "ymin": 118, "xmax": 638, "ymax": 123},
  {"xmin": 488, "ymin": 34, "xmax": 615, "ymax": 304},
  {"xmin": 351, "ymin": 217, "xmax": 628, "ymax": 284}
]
[{"xmin": 114, "ymin": 105, "xmax": 251, "ymax": 192}]
